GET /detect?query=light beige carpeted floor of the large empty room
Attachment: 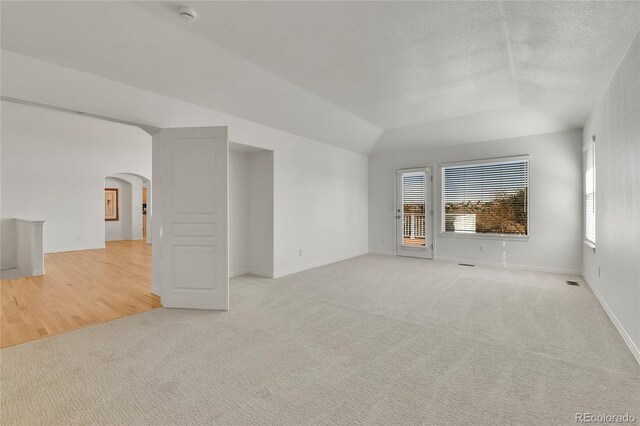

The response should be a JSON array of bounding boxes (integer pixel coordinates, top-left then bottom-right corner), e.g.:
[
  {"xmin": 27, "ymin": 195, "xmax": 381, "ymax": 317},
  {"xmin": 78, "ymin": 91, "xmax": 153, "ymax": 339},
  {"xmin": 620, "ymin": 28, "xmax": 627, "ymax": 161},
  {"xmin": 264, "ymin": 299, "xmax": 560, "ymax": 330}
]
[{"xmin": 0, "ymin": 255, "xmax": 640, "ymax": 425}]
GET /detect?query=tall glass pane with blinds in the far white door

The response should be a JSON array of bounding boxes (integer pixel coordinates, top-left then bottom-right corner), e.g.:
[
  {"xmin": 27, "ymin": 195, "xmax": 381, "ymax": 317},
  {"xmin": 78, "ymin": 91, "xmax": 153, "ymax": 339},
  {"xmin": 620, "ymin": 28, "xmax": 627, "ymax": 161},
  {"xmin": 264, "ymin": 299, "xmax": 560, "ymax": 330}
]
[{"xmin": 402, "ymin": 172, "xmax": 427, "ymax": 247}]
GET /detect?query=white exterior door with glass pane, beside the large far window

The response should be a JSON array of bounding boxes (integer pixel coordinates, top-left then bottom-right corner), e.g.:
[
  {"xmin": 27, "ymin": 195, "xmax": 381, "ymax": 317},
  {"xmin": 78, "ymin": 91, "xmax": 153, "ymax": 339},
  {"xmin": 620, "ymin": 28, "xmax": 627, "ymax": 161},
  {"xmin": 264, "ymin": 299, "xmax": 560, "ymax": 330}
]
[{"xmin": 396, "ymin": 167, "xmax": 433, "ymax": 259}]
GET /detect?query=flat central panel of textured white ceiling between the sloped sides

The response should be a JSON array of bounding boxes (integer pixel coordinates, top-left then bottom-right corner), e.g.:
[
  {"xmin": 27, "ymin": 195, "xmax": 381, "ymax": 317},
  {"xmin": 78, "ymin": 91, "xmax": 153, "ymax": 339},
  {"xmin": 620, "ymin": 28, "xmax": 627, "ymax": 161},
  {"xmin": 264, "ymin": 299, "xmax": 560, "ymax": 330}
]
[{"xmin": 140, "ymin": 2, "xmax": 517, "ymax": 128}]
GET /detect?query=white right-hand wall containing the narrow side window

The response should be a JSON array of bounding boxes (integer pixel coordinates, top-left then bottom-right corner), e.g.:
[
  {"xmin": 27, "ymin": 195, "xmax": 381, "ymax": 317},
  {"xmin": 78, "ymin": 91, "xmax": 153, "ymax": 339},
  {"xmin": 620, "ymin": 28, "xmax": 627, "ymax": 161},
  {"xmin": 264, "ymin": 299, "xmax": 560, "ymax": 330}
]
[{"xmin": 583, "ymin": 32, "xmax": 640, "ymax": 361}]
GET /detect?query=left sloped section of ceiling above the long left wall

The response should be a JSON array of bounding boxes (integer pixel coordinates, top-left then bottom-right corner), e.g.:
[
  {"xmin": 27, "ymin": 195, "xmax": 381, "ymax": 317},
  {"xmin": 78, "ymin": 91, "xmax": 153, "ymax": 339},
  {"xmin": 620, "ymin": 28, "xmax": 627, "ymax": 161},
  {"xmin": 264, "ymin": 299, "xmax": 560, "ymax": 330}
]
[{"xmin": 0, "ymin": 1, "xmax": 382, "ymax": 153}]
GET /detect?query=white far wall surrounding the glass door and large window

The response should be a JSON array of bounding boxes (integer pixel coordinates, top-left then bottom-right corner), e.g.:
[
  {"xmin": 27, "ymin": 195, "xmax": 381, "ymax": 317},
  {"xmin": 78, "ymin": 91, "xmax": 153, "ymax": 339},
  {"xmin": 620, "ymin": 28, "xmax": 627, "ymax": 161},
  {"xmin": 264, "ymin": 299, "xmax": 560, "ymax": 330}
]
[{"xmin": 369, "ymin": 130, "xmax": 582, "ymax": 274}]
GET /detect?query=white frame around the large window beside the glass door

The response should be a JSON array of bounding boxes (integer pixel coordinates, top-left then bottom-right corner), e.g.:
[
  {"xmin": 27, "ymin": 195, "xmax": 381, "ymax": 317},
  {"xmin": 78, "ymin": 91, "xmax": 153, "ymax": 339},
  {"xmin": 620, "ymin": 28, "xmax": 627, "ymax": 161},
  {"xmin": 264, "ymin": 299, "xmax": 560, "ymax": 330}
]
[{"xmin": 440, "ymin": 155, "xmax": 531, "ymax": 241}]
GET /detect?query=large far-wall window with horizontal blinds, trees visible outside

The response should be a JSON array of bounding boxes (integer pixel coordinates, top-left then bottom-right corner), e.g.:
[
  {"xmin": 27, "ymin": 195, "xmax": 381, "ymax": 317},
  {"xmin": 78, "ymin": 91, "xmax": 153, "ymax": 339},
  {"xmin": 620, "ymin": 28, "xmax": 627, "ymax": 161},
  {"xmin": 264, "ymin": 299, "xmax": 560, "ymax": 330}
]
[{"xmin": 442, "ymin": 157, "xmax": 529, "ymax": 236}]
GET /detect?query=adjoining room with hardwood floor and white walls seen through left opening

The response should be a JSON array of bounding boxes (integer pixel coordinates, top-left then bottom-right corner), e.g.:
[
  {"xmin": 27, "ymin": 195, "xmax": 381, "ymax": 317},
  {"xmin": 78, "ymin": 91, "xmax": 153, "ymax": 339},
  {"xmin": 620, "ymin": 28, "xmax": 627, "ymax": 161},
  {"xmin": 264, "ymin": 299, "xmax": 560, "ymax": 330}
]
[{"xmin": 0, "ymin": 101, "xmax": 161, "ymax": 347}]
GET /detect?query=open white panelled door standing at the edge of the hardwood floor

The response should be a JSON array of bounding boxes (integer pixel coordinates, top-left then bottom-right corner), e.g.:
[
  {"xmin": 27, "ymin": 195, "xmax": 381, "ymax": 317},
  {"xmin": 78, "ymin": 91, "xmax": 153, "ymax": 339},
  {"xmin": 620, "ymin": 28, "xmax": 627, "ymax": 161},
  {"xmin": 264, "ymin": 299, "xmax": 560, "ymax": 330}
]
[{"xmin": 152, "ymin": 127, "xmax": 229, "ymax": 310}]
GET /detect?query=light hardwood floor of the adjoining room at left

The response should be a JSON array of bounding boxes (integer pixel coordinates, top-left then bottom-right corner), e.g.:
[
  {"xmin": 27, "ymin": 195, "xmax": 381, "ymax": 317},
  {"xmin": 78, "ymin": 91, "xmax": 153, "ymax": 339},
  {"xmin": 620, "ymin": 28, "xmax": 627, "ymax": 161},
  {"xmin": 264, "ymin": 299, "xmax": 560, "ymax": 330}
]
[{"xmin": 0, "ymin": 241, "xmax": 161, "ymax": 348}]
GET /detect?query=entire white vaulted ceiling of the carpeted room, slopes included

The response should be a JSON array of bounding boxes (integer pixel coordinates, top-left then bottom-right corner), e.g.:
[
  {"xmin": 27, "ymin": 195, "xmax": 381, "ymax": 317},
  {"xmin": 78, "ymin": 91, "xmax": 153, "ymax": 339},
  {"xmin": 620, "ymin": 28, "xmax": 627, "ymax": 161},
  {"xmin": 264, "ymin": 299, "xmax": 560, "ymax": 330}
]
[{"xmin": 2, "ymin": 1, "xmax": 640, "ymax": 152}]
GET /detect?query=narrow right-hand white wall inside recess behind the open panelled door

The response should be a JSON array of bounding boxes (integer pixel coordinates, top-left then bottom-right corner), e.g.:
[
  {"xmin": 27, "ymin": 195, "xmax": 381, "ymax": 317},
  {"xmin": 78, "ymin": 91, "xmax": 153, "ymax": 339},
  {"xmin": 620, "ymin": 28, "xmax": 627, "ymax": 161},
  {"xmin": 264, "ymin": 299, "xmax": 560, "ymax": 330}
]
[{"xmin": 249, "ymin": 151, "xmax": 274, "ymax": 277}]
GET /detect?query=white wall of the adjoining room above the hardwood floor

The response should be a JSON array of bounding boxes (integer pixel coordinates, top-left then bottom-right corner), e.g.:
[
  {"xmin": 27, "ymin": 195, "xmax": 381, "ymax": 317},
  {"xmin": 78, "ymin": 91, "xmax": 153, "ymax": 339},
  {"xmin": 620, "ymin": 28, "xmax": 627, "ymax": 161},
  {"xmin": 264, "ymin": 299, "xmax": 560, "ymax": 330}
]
[{"xmin": 0, "ymin": 101, "xmax": 151, "ymax": 268}]
